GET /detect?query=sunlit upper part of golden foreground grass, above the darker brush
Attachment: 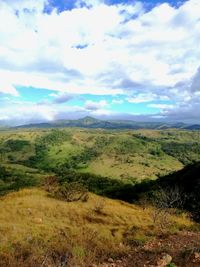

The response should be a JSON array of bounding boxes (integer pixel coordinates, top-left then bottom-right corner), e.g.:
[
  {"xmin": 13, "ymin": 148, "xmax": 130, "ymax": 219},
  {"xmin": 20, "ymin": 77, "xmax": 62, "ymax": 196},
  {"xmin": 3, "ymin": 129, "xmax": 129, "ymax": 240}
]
[{"xmin": 0, "ymin": 189, "xmax": 192, "ymax": 255}]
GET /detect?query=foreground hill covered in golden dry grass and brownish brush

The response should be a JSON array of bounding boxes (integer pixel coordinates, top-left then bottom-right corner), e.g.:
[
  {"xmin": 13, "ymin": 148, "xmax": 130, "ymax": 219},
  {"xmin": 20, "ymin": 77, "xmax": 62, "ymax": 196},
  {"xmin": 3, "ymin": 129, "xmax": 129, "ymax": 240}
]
[{"xmin": 0, "ymin": 189, "xmax": 198, "ymax": 267}]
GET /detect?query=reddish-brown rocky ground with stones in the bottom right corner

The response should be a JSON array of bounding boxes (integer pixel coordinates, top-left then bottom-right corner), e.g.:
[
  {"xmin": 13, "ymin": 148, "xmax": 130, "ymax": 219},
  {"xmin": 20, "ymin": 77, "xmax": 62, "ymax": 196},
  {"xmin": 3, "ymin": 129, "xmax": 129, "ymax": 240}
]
[{"xmin": 92, "ymin": 232, "xmax": 200, "ymax": 267}]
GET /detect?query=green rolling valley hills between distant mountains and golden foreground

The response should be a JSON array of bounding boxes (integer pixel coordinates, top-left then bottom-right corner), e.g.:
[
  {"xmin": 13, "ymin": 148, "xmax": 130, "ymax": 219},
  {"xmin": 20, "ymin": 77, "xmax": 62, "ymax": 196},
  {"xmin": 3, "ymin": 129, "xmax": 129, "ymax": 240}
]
[{"xmin": 0, "ymin": 128, "xmax": 200, "ymax": 195}]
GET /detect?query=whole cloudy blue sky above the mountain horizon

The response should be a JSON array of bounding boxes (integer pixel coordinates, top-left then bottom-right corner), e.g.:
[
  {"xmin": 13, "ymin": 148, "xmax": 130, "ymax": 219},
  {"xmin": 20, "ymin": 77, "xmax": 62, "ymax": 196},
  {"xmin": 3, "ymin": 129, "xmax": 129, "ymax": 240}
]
[{"xmin": 0, "ymin": 0, "xmax": 200, "ymax": 125}]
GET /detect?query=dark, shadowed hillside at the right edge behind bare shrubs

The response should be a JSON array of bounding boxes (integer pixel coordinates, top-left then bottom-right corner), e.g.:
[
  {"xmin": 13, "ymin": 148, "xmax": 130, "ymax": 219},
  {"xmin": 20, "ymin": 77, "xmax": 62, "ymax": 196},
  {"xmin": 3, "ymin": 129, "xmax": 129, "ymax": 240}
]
[{"xmin": 134, "ymin": 162, "xmax": 200, "ymax": 222}]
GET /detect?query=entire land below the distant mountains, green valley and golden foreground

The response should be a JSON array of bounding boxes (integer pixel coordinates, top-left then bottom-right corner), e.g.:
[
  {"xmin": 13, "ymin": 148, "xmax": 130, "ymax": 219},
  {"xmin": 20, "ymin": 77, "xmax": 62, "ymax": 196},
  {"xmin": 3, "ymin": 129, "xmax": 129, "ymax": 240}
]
[{"xmin": 0, "ymin": 127, "xmax": 200, "ymax": 267}]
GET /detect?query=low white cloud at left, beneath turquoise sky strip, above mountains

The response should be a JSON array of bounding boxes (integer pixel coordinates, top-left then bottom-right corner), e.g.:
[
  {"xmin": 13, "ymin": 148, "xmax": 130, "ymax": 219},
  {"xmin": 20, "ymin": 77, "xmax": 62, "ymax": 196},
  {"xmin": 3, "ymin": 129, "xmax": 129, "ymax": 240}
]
[{"xmin": 0, "ymin": 100, "xmax": 112, "ymax": 125}]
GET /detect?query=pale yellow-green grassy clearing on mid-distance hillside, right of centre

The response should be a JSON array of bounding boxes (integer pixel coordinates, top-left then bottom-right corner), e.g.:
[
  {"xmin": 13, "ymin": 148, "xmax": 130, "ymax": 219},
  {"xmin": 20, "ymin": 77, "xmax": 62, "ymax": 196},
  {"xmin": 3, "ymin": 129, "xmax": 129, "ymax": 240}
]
[{"xmin": 83, "ymin": 154, "xmax": 183, "ymax": 180}]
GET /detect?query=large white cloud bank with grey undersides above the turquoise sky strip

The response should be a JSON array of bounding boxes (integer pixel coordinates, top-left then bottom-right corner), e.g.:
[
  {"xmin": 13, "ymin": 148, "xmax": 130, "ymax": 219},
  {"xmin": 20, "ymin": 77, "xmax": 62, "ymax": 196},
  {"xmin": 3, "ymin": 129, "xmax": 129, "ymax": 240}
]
[{"xmin": 0, "ymin": 0, "xmax": 200, "ymax": 123}]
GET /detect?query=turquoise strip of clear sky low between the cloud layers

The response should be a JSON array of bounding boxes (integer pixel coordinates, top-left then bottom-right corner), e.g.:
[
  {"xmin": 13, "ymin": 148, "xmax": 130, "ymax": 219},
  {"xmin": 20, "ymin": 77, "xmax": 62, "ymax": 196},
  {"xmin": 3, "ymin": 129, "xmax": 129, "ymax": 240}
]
[{"xmin": 10, "ymin": 86, "xmax": 172, "ymax": 115}]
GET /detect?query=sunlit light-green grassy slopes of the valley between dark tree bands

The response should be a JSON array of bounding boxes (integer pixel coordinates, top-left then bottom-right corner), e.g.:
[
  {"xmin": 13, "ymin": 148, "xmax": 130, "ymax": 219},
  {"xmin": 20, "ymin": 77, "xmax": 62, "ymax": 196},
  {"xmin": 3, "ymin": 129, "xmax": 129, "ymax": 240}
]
[{"xmin": 0, "ymin": 128, "xmax": 200, "ymax": 179}]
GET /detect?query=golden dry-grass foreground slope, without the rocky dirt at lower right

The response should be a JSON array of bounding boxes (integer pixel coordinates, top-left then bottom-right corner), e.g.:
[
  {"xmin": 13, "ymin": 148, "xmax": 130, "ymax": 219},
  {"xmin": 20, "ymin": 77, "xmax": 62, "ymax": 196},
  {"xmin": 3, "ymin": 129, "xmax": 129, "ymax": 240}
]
[{"xmin": 0, "ymin": 189, "xmax": 193, "ymax": 267}]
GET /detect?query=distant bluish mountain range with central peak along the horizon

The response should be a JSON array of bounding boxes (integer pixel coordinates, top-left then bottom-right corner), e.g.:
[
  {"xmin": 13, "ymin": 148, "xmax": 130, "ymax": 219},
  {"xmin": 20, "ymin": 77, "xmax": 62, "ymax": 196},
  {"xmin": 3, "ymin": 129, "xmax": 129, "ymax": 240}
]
[{"xmin": 15, "ymin": 117, "xmax": 200, "ymax": 130}]
